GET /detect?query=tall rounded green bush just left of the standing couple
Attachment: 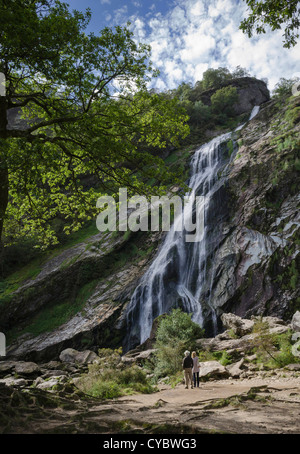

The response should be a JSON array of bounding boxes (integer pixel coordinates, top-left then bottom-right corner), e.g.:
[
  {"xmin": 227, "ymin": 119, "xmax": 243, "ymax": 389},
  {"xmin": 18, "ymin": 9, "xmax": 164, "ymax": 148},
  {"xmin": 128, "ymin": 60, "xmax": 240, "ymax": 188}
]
[{"xmin": 155, "ymin": 309, "xmax": 204, "ymax": 376}]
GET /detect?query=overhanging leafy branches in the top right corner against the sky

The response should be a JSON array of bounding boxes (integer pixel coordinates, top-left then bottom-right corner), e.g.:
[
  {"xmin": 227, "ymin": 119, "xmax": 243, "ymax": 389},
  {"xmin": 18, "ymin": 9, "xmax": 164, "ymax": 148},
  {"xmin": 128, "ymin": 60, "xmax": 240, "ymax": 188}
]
[{"xmin": 240, "ymin": 0, "xmax": 300, "ymax": 48}]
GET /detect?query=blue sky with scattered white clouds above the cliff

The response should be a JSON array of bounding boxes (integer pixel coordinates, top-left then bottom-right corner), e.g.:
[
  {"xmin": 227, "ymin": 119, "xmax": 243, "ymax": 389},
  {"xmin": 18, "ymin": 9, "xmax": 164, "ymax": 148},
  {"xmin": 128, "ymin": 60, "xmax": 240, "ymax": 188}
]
[{"xmin": 66, "ymin": 0, "xmax": 300, "ymax": 91}]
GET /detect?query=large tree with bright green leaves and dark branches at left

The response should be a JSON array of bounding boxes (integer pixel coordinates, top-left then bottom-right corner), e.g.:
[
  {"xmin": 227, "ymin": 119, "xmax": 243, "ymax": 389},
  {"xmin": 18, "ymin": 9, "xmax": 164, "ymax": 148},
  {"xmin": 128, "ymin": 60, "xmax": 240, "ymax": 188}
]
[{"xmin": 0, "ymin": 0, "xmax": 188, "ymax": 245}]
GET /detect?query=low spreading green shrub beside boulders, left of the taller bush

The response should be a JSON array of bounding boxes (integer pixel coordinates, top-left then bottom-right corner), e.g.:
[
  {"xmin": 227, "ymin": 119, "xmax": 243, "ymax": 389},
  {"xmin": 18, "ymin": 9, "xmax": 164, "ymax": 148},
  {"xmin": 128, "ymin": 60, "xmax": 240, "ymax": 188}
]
[{"xmin": 77, "ymin": 349, "xmax": 157, "ymax": 399}]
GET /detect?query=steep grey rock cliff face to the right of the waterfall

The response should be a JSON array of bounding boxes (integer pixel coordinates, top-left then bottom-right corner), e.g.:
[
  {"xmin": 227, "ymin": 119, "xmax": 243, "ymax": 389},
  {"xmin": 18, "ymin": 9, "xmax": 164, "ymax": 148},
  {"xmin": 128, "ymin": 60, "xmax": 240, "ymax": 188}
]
[{"xmin": 202, "ymin": 97, "xmax": 300, "ymax": 328}]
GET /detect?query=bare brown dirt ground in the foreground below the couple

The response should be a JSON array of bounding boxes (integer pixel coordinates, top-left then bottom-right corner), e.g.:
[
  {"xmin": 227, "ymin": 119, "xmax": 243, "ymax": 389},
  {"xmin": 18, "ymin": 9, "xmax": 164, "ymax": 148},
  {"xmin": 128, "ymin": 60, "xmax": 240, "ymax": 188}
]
[{"xmin": 5, "ymin": 377, "xmax": 300, "ymax": 434}]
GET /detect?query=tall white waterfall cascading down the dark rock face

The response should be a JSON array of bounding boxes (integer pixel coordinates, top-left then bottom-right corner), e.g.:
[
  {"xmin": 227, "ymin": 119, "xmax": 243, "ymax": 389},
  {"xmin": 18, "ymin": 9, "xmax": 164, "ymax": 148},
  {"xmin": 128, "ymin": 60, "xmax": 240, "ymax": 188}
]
[{"xmin": 124, "ymin": 106, "xmax": 258, "ymax": 350}]
